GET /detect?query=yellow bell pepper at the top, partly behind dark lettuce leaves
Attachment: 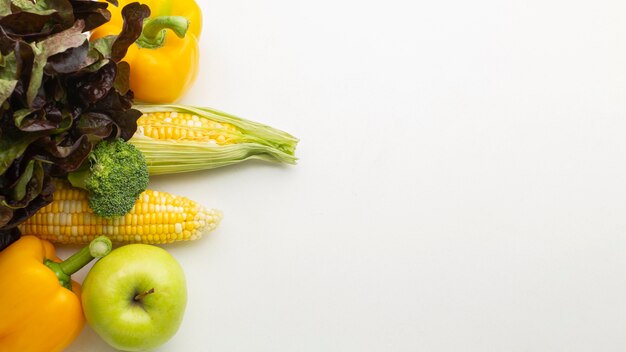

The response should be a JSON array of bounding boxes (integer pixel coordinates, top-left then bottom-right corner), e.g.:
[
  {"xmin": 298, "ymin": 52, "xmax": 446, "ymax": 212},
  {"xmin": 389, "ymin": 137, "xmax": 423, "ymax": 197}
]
[{"xmin": 91, "ymin": 0, "xmax": 202, "ymax": 103}]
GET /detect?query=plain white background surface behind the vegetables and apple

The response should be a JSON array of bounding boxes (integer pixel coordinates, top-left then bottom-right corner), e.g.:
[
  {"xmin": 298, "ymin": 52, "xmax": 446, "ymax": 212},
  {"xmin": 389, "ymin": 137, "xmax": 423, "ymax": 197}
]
[{"xmin": 62, "ymin": 0, "xmax": 626, "ymax": 352}]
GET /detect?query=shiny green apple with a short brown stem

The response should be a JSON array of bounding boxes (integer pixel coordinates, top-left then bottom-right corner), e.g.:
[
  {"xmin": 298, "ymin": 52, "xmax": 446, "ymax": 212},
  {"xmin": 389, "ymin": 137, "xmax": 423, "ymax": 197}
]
[{"xmin": 82, "ymin": 244, "xmax": 187, "ymax": 351}]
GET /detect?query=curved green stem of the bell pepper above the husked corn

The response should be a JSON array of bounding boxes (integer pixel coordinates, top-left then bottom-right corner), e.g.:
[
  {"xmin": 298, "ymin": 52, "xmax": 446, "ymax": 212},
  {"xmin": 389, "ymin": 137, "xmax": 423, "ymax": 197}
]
[{"xmin": 136, "ymin": 16, "xmax": 189, "ymax": 49}]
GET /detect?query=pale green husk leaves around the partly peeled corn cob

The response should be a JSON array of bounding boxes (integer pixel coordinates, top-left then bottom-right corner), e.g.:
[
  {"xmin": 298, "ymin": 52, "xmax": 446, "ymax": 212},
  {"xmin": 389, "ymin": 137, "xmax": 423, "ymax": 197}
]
[{"xmin": 130, "ymin": 105, "xmax": 298, "ymax": 175}]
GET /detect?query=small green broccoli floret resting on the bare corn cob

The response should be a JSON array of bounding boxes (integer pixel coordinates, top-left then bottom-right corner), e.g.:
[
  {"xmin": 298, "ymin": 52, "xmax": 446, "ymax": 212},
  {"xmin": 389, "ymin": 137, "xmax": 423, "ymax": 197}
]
[{"xmin": 68, "ymin": 138, "xmax": 148, "ymax": 218}]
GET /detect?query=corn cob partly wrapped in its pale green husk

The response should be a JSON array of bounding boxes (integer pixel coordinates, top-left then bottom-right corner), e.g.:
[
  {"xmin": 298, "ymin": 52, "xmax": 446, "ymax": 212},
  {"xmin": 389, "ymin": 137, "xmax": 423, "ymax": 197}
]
[{"xmin": 130, "ymin": 105, "xmax": 298, "ymax": 175}]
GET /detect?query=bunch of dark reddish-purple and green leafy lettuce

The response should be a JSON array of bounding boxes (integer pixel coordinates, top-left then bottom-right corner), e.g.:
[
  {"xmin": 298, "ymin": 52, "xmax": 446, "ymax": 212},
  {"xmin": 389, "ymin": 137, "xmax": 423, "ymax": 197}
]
[{"xmin": 0, "ymin": 0, "xmax": 150, "ymax": 250}]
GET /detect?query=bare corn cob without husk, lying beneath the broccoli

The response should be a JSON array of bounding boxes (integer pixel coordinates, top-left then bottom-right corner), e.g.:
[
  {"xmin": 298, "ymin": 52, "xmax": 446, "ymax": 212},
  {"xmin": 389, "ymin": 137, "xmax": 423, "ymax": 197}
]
[{"xmin": 19, "ymin": 180, "xmax": 222, "ymax": 244}]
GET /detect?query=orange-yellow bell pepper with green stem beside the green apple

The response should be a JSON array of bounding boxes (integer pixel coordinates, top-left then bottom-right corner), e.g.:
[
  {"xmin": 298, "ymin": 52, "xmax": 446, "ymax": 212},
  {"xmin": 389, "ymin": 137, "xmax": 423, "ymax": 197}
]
[{"xmin": 0, "ymin": 236, "xmax": 111, "ymax": 352}]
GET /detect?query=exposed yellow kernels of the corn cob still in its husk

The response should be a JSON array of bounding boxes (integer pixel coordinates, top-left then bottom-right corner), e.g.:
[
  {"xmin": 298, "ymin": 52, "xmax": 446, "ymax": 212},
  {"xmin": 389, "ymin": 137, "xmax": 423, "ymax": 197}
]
[{"xmin": 137, "ymin": 111, "xmax": 242, "ymax": 145}]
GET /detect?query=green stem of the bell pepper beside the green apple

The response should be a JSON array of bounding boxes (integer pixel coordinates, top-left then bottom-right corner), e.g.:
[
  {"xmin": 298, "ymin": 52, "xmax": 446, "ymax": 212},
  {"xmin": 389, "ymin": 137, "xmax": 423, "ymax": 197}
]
[{"xmin": 45, "ymin": 236, "xmax": 113, "ymax": 290}]
